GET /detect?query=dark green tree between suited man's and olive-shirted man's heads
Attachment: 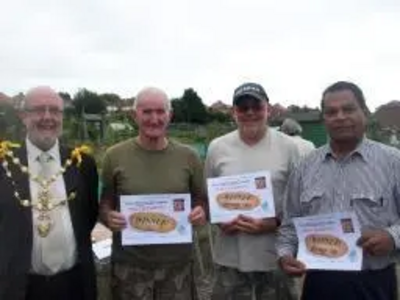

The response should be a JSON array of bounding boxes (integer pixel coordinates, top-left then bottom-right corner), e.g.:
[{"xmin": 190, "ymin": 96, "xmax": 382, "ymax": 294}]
[{"xmin": 73, "ymin": 89, "xmax": 107, "ymax": 115}]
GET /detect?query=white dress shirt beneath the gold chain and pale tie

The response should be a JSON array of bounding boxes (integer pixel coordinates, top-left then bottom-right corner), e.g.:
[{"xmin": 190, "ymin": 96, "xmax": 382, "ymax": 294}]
[{"xmin": 26, "ymin": 139, "xmax": 76, "ymax": 275}]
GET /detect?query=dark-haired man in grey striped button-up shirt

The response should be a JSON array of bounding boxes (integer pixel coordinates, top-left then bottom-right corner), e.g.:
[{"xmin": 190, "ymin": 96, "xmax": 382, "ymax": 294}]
[{"xmin": 277, "ymin": 82, "xmax": 400, "ymax": 300}]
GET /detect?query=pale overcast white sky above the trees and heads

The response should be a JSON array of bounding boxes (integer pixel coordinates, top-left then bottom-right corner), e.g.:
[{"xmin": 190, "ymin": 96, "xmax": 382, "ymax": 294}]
[{"xmin": 0, "ymin": 0, "xmax": 400, "ymax": 109}]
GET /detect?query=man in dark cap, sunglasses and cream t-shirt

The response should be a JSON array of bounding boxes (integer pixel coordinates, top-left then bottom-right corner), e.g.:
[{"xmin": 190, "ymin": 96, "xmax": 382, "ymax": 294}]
[{"xmin": 205, "ymin": 83, "xmax": 299, "ymax": 300}]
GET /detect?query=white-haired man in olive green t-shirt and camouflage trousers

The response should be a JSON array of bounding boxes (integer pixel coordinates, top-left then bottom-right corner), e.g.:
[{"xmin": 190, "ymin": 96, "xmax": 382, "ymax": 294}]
[{"xmin": 101, "ymin": 88, "xmax": 206, "ymax": 300}]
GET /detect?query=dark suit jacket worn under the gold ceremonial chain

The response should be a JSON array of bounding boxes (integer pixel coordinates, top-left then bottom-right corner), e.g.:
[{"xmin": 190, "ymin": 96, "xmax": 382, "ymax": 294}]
[{"xmin": 0, "ymin": 144, "xmax": 98, "ymax": 300}]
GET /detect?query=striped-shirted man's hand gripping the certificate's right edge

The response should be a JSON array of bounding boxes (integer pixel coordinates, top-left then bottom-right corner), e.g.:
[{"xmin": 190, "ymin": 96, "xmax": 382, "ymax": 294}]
[{"xmin": 358, "ymin": 230, "xmax": 395, "ymax": 256}]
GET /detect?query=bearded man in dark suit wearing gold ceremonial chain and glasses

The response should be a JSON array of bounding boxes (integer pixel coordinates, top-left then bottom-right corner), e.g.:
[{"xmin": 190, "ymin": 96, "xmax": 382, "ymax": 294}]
[{"xmin": 0, "ymin": 87, "xmax": 98, "ymax": 300}]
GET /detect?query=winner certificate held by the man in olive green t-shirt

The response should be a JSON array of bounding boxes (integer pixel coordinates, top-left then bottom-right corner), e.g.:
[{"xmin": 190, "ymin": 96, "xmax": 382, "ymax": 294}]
[{"xmin": 120, "ymin": 194, "xmax": 193, "ymax": 245}]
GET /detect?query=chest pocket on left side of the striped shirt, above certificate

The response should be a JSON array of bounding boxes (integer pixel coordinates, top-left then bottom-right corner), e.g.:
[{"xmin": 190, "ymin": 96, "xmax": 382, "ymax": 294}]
[{"xmin": 300, "ymin": 189, "xmax": 329, "ymax": 215}]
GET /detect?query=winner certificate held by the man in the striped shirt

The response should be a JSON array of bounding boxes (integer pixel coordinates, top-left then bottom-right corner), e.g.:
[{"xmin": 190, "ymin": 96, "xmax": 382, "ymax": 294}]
[{"xmin": 293, "ymin": 212, "xmax": 362, "ymax": 271}]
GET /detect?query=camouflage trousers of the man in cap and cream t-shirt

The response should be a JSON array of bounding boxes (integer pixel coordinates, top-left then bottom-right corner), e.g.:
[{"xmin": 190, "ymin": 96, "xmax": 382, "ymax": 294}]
[{"xmin": 211, "ymin": 266, "xmax": 299, "ymax": 300}]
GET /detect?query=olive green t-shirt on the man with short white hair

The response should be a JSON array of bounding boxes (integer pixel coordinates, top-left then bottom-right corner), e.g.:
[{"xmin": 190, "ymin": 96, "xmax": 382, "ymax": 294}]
[{"xmin": 102, "ymin": 138, "xmax": 206, "ymax": 267}]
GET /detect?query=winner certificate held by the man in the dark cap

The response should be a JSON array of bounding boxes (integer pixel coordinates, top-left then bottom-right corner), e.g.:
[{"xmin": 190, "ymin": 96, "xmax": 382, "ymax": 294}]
[{"xmin": 207, "ymin": 172, "xmax": 275, "ymax": 224}]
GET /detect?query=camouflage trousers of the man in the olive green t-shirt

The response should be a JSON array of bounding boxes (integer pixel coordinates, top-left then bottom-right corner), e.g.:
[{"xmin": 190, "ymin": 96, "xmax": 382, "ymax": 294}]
[{"xmin": 111, "ymin": 263, "xmax": 197, "ymax": 300}]
